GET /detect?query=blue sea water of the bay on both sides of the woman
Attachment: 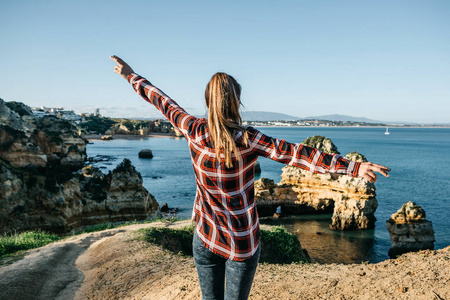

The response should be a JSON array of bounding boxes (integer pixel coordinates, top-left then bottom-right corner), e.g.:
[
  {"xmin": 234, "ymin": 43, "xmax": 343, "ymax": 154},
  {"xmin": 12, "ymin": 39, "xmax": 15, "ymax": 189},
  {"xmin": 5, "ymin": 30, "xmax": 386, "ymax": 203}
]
[{"xmin": 87, "ymin": 127, "xmax": 450, "ymax": 263}]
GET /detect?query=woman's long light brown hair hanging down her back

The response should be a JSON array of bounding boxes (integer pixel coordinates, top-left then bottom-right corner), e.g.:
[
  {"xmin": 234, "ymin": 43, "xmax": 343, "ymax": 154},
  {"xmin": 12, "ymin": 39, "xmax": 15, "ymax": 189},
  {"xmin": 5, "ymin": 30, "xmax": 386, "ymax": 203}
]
[{"xmin": 205, "ymin": 73, "xmax": 248, "ymax": 168}]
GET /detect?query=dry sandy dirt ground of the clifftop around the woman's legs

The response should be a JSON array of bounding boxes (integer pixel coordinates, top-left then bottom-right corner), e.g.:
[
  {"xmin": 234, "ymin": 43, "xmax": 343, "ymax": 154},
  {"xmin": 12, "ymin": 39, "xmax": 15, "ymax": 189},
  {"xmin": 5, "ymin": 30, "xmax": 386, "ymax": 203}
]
[{"xmin": 0, "ymin": 221, "xmax": 450, "ymax": 300}]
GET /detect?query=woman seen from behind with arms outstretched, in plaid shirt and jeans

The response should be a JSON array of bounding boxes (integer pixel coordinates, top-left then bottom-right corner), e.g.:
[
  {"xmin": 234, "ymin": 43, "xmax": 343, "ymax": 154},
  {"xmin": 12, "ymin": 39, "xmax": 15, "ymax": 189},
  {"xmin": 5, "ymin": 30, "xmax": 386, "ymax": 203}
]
[{"xmin": 111, "ymin": 56, "xmax": 389, "ymax": 299}]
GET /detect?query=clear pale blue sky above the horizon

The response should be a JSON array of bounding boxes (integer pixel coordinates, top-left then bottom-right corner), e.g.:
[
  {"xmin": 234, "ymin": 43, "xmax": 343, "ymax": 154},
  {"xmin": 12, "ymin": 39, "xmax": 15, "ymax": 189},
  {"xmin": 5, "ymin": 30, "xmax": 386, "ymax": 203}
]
[{"xmin": 0, "ymin": 0, "xmax": 450, "ymax": 123}]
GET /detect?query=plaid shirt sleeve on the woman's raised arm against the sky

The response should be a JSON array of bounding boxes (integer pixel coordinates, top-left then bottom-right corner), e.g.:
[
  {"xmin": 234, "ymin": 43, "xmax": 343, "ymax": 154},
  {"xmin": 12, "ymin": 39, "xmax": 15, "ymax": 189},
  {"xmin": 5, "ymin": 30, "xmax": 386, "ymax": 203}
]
[{"xmin": 128, "ymin": 73, "xmax": 196, "ymax": 136}]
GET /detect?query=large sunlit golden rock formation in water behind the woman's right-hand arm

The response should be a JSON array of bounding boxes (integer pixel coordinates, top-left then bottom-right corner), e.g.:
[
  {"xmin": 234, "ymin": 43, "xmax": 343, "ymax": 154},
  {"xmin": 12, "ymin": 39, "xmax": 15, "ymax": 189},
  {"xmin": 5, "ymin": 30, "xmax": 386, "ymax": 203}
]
[{"xmin": 255, "ymin": 136, "xmax": 378, "ymax": 230}]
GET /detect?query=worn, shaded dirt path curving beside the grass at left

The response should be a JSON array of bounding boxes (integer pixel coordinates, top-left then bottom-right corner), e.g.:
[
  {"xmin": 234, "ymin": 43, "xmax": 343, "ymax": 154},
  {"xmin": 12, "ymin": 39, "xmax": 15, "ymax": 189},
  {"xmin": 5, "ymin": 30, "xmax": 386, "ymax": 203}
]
[{"xmin": 0, "ymin": 221, "xmax": 189, "ymax": 300}]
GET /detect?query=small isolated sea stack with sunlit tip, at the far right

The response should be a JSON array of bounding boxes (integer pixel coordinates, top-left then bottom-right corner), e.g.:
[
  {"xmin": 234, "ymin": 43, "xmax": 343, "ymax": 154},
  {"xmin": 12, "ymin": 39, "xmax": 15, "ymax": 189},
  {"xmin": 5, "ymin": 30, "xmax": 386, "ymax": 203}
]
[{"xmin": 386, "ymin": 201, "xmax": 435, "ymax": 258}]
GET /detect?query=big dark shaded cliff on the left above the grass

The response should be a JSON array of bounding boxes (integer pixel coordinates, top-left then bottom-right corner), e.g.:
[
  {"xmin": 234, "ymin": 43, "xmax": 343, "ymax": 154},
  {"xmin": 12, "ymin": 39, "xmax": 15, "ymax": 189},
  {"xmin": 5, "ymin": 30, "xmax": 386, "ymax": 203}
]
[{"xmin": 0, "ymin": 100, "xmax": 158, "ymax": 233}]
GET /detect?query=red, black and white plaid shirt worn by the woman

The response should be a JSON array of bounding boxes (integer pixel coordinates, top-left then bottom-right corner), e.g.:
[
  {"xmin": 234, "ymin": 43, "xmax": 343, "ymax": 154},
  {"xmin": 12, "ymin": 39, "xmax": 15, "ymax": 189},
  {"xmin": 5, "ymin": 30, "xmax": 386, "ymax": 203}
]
[{"xmin": 128, "ymin": 74, "xmax": 360, "ymax": 261}]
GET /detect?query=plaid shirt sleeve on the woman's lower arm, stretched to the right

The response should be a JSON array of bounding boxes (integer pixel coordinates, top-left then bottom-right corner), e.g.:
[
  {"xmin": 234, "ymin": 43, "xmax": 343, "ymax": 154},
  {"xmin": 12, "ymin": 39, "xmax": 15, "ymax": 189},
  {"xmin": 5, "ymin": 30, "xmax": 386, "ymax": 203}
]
[{"xmin": 251, "ymin": 128, "xmax": 361, "ymax": 177}]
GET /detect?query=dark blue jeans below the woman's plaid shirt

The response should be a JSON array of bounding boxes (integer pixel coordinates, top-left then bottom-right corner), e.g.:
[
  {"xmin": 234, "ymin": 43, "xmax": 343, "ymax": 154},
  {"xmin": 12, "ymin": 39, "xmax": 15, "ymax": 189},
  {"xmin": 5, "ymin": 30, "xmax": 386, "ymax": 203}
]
[{"xmin": 192, "ymin": 231, "xmax": 261, "ymax": 300}]
